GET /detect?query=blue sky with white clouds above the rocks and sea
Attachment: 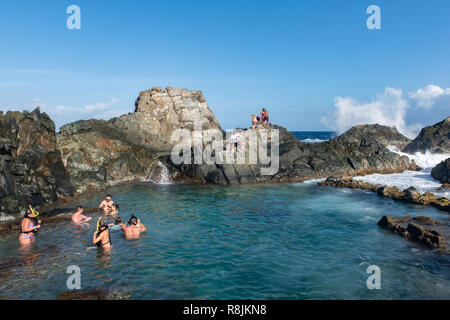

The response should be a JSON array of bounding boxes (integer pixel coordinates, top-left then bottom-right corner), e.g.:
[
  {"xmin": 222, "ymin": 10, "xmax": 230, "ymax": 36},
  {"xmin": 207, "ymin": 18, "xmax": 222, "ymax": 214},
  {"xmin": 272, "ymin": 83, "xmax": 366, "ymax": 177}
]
[{"xmin": 0, "ymin": 0, "xmax": 450, "ymax": 132}]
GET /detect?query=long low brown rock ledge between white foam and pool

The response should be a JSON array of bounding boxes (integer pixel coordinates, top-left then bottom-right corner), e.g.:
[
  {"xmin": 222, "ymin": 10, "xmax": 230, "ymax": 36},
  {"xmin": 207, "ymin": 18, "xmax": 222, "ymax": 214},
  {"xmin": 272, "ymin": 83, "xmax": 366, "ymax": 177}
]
[{"xmin": 318, "ymin": 177, "xmax": 450, "ymax": 212}]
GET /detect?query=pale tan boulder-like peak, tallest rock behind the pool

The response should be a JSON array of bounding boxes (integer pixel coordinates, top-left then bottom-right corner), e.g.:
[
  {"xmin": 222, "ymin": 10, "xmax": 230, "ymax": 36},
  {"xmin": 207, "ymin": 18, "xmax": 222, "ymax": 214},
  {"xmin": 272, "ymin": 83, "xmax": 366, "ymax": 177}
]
[{"xmin": 109, "ymin": 87, "xmax": 222, "ymax": 152}]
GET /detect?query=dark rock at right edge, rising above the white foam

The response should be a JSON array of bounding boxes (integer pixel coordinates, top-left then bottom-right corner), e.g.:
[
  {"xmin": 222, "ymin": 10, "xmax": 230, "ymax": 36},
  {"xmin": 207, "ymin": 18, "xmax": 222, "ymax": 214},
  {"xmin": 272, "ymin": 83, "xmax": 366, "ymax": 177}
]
[{"xmin": 403, "ymin": 117, "xmax": 450, "ymax": 153}]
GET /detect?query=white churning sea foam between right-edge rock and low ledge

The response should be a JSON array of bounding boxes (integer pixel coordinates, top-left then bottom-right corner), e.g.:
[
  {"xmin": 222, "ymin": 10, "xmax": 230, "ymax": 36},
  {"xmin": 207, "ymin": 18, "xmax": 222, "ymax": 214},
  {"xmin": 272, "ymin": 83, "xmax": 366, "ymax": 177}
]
[{"xmin": 355, "ymin": 146, "xmax": 450, "ymax": 198}]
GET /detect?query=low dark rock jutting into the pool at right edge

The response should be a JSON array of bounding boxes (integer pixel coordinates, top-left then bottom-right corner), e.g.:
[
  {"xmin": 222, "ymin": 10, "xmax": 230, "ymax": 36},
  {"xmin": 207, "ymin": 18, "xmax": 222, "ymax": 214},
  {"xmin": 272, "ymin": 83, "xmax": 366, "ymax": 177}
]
[{"xmin": 378, "ymin": 216, "xmax": 450, "ymax": 249}]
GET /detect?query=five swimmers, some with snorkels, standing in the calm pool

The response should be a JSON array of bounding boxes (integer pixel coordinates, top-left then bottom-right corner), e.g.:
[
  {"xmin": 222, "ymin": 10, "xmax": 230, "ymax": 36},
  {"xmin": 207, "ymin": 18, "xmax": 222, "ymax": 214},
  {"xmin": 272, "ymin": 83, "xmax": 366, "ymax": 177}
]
[{"xmin": 19, "ymin": 195, "xmax": 147, "ymax": 249}]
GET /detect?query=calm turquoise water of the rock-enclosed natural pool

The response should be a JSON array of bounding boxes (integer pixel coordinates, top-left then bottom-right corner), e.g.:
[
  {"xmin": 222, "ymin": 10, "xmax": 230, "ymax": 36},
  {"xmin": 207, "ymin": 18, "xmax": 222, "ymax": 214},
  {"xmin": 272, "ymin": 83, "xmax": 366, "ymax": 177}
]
[{"xmin": 0, "ymin": 183, "xmax": 450, "ymax": 299}]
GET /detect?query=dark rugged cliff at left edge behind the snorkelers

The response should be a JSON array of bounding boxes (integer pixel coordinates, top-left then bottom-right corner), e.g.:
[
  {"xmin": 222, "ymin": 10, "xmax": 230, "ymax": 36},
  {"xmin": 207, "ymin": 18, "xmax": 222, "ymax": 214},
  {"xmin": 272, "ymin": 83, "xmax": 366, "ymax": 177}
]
[{"xmin": 0, "ymin": 109, "xmax": 74, "ymax": 214}]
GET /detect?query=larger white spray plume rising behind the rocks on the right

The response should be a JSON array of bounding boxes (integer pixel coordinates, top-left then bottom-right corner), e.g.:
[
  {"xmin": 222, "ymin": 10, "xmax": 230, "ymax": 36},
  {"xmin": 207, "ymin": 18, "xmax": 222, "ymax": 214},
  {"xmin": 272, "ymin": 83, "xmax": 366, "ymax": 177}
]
[{"xmin": 322, "ymin": 87, "xmax": 422, "ymax": 138}]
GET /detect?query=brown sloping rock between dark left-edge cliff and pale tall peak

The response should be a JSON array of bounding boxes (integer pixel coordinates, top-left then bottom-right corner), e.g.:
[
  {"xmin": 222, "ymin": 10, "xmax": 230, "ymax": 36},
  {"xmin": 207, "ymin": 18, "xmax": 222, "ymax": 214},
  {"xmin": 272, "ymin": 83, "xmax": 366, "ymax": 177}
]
[{"xmin": 57, "ymin": 120, "xmax": 171, "ymax": 192}]
